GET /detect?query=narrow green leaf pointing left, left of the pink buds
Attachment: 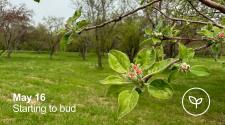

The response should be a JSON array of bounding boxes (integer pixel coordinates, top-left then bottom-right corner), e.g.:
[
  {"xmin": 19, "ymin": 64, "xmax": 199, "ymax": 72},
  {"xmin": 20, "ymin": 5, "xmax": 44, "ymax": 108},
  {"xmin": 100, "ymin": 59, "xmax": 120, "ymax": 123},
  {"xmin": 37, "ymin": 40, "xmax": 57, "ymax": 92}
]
[{"xmin": 100, "ymin": 75, "xmax": 132, "ymax": 85}]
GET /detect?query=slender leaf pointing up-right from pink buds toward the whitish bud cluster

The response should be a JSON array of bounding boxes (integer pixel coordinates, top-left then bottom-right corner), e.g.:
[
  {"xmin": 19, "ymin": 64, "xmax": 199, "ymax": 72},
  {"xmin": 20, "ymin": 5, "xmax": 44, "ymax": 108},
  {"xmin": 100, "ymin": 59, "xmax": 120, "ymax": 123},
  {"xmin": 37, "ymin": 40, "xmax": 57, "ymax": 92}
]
[{"xmin": 148, "ymin": 59, "xmax": 174, "ymax": 75}]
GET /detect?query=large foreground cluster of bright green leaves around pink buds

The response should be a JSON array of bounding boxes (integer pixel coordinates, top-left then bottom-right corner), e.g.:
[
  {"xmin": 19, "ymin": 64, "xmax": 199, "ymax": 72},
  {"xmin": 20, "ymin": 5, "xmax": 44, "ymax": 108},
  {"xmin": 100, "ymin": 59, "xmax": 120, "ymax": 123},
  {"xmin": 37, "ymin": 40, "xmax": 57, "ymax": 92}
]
[{"xmin": 101, "ymin": 40, "xmax": 209, "ymax": 119}]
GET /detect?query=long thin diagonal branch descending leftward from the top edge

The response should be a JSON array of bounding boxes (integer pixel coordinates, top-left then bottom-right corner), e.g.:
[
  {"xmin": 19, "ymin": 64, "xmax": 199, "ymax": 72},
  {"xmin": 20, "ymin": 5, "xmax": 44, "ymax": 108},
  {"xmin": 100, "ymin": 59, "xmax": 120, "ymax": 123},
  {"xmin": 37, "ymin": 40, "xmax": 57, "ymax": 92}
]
[{"xmin": 78, "ymin": 0, "xmax": 161, "ymax": 34}]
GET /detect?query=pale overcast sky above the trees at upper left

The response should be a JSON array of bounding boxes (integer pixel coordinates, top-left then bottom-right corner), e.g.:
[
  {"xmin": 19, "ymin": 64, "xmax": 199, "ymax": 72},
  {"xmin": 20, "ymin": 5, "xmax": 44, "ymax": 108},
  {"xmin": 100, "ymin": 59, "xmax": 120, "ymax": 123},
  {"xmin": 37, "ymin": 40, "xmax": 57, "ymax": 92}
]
[{"xmin": 9, "ymin": 0, "xmax": 74, "ymax": 24}]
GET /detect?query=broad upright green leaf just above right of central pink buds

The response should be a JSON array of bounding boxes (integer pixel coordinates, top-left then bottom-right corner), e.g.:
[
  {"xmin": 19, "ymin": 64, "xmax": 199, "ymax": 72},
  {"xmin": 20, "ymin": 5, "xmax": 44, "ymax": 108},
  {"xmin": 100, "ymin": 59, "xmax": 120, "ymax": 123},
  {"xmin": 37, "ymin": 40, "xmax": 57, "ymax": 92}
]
[{"xmin": 135, "ymin": 49, "xmax": 156, "ymax": 70}]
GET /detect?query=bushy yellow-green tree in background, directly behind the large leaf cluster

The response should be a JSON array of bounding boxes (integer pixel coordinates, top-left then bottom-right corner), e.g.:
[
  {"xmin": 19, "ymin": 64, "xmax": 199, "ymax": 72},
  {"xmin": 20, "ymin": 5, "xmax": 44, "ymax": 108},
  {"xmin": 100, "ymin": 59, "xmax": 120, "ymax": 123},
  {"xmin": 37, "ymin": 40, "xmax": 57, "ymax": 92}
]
[{"xmin": 111, "ymin": 16, "xmax": 144, "ymax": 62}]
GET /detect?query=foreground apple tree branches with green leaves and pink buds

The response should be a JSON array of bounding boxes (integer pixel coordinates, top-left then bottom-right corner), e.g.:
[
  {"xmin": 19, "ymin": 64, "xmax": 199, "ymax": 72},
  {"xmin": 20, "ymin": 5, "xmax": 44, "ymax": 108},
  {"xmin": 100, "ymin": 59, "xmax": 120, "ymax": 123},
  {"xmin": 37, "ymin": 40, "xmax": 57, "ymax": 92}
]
[{"xmin": 63, "ymin": 0, "xmax": 225, "ymax": 118}]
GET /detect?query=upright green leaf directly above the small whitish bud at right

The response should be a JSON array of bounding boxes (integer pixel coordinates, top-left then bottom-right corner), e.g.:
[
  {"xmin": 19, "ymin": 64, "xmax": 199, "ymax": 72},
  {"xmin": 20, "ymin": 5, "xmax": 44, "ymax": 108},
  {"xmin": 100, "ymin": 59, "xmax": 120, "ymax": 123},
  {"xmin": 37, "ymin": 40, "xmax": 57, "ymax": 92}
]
[{"xmin": 178, "ymin": 43, "xmax": 195, "ymax": 62}]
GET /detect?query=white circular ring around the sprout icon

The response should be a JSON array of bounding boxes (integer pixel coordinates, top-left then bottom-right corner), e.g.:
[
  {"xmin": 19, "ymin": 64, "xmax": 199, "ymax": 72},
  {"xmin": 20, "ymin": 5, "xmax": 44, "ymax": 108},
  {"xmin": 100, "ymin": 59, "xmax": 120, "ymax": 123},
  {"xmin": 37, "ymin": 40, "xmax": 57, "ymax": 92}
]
[{"xmin": 182, "ymin": 87, "xmax": 210, "ymax": 117}]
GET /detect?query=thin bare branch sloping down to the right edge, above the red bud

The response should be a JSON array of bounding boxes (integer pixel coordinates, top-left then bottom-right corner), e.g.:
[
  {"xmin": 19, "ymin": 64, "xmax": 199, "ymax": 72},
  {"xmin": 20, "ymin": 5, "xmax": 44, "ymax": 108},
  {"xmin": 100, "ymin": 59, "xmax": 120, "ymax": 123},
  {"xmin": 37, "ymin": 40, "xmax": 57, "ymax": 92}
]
[{"xmin": 154, "ymin": 7, "xmax": 225, "ymax": 28}]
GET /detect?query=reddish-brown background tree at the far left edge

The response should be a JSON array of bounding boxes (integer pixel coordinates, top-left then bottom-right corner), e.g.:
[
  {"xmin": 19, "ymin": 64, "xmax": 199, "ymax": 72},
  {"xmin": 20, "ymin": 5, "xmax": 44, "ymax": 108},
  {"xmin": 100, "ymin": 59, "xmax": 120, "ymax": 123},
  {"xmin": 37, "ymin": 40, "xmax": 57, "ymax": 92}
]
[{"xmin": 0, "ymin": 3, "xmax": 31, "ymax": 57}]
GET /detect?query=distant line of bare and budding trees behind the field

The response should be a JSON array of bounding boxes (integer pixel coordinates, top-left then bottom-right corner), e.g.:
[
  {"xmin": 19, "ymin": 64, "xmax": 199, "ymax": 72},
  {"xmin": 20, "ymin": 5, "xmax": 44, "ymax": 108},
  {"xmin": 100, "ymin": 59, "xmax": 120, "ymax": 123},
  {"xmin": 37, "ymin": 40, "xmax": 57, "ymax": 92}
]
[{"xmin": 0, "ymin": 0, "xmax": 225, "ymax": 66}]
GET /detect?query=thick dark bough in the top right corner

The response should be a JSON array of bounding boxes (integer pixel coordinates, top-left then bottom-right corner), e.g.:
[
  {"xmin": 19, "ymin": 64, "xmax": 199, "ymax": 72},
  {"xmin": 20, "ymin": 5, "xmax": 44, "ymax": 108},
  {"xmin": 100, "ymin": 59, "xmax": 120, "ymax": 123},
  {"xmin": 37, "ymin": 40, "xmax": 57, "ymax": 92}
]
[{"xmin": 199, "ymin": 0, "xmax": 225, "ymax": 14}]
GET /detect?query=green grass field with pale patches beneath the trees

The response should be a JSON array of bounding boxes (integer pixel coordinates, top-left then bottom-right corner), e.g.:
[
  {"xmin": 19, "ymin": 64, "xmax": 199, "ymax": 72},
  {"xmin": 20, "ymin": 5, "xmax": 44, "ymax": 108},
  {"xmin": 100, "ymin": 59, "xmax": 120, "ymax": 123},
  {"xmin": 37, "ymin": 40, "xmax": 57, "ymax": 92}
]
[{"xmin": 0, "ymin": 53, "xmax": 225, "ymax": 125}]
